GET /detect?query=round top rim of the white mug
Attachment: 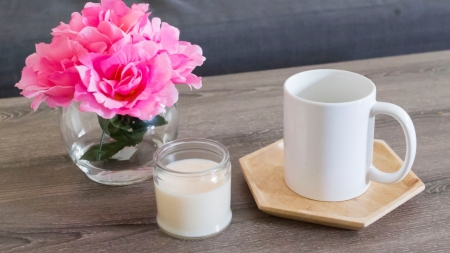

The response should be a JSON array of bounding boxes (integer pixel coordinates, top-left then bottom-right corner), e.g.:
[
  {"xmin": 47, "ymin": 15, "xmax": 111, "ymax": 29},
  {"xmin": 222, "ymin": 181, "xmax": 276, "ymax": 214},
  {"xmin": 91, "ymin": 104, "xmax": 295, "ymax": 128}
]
[{"xmin": 283, "ymin": 69, "xmax": 376, "ymax": 106}]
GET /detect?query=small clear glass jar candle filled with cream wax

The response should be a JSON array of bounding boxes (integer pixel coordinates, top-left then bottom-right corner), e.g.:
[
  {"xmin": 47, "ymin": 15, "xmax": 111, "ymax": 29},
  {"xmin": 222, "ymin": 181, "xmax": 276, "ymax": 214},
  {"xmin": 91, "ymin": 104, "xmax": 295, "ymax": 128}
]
[{"xmin": 153, "ymin": 138, "xmax": 232, "ymax": 239}]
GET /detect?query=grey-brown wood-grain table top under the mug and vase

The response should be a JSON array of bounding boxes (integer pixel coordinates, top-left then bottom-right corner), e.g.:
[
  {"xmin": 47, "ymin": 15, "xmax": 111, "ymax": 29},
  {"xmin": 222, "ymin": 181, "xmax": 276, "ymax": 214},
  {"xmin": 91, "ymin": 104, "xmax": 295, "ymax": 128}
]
[{"xmin": 0, "ymin": 51, "xmax": 450, "ymax": 253}]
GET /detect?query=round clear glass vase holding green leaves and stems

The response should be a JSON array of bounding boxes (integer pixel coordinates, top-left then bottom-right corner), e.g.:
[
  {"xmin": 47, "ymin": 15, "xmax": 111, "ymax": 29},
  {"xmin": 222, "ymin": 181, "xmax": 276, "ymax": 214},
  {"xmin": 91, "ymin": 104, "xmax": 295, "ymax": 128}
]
[{"xmin": 60, "ymin": 103, "xmax": 180, "ymax": 185}]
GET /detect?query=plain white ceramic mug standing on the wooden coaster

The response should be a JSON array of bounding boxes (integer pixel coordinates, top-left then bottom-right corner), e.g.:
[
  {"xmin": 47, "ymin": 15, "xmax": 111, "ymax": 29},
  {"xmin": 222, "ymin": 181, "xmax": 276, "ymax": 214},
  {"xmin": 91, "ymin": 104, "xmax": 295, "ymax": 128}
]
[{"xmin": 284, "ymin": 69, "xmax": 416, "ymax": 201}]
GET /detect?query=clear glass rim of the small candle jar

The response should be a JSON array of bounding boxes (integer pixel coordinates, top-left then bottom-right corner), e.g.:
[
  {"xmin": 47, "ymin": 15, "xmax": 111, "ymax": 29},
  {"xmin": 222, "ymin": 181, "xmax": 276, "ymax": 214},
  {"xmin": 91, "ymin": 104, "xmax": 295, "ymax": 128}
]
[{"xmin": 153, "ymin": 138, "xmax": 230, "ymax": 176}]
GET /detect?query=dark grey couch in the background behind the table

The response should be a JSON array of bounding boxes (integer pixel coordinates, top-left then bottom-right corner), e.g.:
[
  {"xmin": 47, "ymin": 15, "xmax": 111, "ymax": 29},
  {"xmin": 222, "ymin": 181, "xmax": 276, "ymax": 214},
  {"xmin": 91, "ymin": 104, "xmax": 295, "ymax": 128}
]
[{"xmin": 0, "ymin": 0, "xmax": 450, "ymax": 98}]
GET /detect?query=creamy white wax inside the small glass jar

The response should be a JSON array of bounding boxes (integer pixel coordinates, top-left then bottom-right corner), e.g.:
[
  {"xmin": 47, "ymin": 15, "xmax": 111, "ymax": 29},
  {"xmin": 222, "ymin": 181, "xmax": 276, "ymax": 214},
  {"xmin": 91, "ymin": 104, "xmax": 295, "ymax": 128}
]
[{"xmin": 155, "ymin": 159, "xmax": 232, "ymax": 237}]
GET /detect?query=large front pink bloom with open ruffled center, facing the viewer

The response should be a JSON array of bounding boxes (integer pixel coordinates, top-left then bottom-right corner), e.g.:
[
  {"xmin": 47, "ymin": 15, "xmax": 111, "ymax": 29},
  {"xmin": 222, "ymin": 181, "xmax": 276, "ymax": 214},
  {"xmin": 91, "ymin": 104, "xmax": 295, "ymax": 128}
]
[{"xmin": 75, "ymin": 41, "xmax": 178, "ymax": 120}]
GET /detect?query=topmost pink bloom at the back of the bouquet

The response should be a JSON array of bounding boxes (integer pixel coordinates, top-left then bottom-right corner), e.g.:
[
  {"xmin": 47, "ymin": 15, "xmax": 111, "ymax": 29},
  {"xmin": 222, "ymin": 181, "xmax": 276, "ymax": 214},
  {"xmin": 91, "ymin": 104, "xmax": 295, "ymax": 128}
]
[{"xmin": 52, "ymin": 0, "xmax": 150, "ymax": 53}]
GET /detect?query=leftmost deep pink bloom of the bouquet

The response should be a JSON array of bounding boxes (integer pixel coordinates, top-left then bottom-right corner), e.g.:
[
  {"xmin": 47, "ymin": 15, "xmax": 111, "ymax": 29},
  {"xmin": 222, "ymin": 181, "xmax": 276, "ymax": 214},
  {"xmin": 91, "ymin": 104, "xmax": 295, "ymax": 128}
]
[{"xmin": 16, "ymin": 36, "xmax": 86, "ymax": 110}]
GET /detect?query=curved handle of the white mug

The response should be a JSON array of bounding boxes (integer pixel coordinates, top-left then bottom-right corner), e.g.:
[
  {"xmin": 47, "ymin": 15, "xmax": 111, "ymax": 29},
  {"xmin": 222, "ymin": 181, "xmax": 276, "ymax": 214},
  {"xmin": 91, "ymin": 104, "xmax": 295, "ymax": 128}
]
[{"xmin": 369, "ymin": 102, "xmax": 417, "ymax": 184}]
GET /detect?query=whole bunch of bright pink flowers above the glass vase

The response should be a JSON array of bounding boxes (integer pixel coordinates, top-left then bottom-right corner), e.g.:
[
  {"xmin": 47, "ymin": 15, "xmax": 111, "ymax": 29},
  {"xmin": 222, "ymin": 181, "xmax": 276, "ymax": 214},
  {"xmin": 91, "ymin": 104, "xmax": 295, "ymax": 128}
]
[{"xmin": 16, "ymin": 0, "xmax": 205, "ymax": 120}]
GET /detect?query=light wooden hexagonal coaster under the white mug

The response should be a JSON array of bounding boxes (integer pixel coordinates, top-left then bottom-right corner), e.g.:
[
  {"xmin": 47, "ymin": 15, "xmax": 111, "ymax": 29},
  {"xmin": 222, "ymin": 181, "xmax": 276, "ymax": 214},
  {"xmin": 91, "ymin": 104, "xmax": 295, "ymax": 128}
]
[{"xmin": 239, "ymin": 140, "xmax": 425, "ymax": 230}]
